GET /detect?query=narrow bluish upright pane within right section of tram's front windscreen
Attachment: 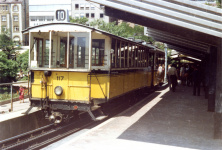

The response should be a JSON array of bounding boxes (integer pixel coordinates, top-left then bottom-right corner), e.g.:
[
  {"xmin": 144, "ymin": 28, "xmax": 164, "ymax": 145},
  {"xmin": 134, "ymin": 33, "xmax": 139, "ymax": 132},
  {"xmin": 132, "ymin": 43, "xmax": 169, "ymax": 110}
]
[{"xmin": 77, "ymin": 37, "xmax": 86, "ymax": 67}]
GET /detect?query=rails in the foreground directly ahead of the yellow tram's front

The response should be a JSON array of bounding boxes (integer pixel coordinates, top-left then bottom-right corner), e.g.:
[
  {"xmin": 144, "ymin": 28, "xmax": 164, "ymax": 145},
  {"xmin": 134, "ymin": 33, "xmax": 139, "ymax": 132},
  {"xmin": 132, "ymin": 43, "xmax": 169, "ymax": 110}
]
[{"xmin": 0, "ymin": 113, "xmax": 94, "ymax": 150}]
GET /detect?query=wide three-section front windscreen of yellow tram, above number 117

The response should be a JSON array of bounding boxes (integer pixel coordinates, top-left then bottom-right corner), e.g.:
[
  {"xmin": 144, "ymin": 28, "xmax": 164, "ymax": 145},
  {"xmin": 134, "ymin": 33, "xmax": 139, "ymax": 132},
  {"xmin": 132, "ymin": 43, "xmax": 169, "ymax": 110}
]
[{"xmin": 30, "ymin": 32, "xmax": 89, "ymax": 69}]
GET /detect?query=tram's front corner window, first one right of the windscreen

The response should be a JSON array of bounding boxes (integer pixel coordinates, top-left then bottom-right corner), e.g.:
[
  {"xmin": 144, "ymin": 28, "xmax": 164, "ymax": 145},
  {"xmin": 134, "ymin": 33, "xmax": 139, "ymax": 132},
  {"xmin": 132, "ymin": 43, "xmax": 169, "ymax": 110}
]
[{"xmin": 92, "ymin": 39, "xmax": 105, "ymax": 66}]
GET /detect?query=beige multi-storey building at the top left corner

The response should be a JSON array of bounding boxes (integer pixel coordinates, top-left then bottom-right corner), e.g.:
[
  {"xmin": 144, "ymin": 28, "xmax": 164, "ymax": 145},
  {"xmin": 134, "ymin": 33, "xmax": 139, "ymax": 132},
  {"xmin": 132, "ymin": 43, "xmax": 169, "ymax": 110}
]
[{"xmin": 0, "ymin": 0, "xmax": 28, "ymax": 44}]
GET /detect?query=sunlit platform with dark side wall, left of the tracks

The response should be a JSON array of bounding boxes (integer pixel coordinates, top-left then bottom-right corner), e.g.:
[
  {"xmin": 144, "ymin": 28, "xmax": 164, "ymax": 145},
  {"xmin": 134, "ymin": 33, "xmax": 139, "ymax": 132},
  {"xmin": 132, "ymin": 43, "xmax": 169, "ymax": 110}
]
[{"xmin": 0, "ymin": 99, "xmax": 49, "ymax": 141}]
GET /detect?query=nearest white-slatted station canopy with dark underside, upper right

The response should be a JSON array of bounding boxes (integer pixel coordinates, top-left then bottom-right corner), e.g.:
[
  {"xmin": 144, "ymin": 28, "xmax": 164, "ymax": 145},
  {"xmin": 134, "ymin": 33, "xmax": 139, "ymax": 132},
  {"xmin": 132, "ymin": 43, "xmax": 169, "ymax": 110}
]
[{"xmin": 88, "ymin": 0, "xmax": 222, "ymax": 59}]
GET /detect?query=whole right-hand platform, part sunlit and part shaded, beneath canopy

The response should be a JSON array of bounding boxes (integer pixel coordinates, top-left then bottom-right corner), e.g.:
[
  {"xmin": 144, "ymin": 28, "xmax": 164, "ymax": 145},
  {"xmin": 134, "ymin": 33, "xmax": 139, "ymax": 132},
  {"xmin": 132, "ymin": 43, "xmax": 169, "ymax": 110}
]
[{"xmin": 44, "ymin": 85, "xmax": 222, "ymax": 150}]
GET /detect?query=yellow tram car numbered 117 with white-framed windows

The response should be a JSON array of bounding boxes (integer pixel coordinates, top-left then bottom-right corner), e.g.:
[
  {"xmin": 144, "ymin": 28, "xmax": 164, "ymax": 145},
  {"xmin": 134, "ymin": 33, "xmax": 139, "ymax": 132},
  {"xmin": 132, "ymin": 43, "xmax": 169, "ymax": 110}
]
[{"xmin": 23, "ymin": 23, "xmax": 164, "ymax": 123}]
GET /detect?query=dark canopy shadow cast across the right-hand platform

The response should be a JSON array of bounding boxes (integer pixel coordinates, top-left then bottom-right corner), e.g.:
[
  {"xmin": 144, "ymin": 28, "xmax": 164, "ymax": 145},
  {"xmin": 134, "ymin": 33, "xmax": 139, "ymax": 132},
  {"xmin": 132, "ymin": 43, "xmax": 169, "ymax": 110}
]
[{"xmin": 118, "ymin": 85, "xmax": 222, "ymax": 150}]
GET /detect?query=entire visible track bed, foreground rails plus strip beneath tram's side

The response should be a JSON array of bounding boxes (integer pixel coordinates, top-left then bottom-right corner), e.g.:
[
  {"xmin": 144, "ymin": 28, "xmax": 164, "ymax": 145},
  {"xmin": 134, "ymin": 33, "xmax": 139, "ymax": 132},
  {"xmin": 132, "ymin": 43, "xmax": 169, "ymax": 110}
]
[{"xmin": 0, "ymin": 88, "xmax": 155, "ymax": 150}]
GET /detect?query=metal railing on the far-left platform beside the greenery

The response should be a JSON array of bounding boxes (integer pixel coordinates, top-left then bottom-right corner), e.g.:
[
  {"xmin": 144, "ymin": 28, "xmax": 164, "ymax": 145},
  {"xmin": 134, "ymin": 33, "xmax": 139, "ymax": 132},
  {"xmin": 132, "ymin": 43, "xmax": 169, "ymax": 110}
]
[{"xmin": 0, "ymin": 81, "xmax": 30, "ymax": 111}]
